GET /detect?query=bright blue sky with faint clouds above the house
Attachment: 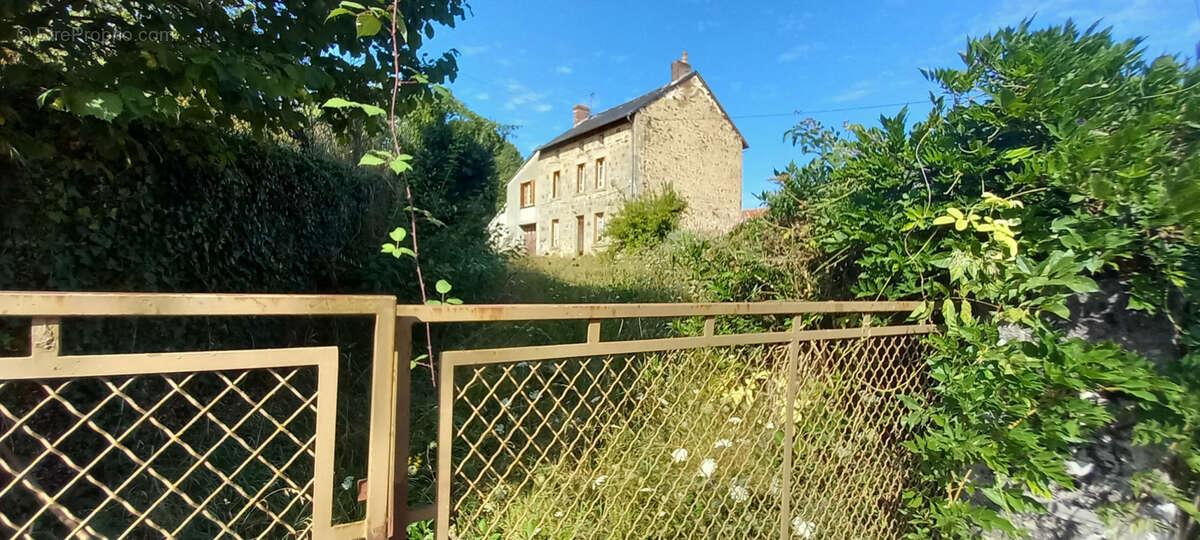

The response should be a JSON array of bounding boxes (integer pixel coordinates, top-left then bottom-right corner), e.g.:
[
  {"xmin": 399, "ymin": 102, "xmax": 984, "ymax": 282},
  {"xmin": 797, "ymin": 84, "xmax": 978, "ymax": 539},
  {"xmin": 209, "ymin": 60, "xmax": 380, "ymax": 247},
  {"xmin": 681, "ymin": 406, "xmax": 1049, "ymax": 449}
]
[{"xmin": 425, "ymin": 0, "xmax": 1200, "ymax": 208}]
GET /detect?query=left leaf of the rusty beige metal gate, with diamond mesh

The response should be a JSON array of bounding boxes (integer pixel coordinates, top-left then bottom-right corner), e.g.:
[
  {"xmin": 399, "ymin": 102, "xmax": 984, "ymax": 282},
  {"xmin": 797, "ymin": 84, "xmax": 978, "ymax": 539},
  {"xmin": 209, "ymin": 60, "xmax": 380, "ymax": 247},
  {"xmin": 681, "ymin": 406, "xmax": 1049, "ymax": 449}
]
[{"xmin": 0, "ymin": 293, "xmax": 396, "ymax": 539}]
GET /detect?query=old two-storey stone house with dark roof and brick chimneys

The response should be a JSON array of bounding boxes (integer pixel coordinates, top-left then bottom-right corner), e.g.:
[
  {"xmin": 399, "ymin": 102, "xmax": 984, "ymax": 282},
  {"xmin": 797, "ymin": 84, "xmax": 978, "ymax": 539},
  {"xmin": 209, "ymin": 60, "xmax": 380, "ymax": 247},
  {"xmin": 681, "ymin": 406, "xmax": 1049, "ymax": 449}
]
[{"xmin": 492, "ymin": 53, "xmax": 748, "ymax": 256}]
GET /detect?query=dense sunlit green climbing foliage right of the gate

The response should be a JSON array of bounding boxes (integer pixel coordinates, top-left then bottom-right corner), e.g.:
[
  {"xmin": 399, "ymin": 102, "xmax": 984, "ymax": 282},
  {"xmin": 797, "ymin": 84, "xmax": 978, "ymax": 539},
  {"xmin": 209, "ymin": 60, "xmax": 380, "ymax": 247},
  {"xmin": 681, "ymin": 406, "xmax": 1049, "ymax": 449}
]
[{"xmin": 764, "ymin": 23, "xmax": 1200, "ymax": 538}]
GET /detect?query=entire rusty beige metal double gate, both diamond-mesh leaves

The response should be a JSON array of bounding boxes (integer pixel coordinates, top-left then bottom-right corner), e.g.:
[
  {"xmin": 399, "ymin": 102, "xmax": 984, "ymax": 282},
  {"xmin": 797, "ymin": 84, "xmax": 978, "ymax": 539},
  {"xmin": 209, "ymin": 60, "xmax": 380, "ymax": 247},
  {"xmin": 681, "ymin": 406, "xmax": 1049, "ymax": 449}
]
[{"xmin": 0, "ymin": 292, "xmax": 934, "ymax": 539}]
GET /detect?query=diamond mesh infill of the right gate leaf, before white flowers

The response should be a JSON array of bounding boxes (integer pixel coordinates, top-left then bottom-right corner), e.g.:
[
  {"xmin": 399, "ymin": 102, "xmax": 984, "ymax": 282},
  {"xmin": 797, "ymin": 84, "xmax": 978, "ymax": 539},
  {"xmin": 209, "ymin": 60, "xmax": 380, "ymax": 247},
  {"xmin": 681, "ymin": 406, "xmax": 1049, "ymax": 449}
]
[{"xmin": 450, "ymin": 336, "xmax": 924, "ymax": 539}]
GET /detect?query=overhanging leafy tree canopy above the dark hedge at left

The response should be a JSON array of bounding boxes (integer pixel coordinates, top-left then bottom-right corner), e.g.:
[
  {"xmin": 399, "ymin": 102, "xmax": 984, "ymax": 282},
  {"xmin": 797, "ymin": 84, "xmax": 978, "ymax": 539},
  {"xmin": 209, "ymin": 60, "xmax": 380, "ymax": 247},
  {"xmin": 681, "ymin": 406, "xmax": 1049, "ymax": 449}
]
[{"xmin": 0, "ymin": 0, "xmax": 467, "ymax": 155}]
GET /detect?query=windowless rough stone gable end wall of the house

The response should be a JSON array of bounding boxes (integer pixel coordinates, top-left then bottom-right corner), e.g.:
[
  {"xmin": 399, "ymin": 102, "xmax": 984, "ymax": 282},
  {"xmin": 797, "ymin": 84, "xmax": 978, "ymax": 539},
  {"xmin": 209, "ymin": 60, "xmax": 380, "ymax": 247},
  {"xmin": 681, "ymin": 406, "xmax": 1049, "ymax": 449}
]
[{"xmin": 634, "ymin": 76, "xmax": 743, "ymax": 233}]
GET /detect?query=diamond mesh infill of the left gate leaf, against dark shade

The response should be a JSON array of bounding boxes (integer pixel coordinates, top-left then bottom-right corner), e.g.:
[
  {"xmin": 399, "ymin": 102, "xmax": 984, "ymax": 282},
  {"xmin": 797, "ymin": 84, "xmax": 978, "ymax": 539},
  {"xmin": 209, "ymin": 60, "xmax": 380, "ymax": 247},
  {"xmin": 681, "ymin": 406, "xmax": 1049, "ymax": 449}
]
[{"xmin": 0, "ymin": 367, "xmax": 317, "ymax": 539}]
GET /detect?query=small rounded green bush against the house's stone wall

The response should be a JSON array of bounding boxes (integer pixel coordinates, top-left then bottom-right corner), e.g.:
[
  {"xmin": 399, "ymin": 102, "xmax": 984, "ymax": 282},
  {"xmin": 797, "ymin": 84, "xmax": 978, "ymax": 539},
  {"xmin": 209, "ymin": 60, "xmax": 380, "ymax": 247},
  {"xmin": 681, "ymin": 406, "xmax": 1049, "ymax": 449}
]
[{"xmin": 605, "ymin": 186, "xmax": 688, "ymax": 251}]
